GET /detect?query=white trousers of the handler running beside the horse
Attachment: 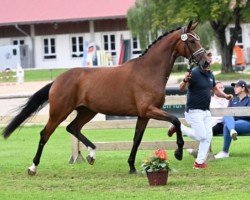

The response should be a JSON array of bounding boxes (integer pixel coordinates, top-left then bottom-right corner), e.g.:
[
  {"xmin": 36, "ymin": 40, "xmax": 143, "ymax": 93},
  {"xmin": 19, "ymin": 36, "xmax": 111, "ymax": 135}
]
[{"xmin": 181, "ymin": 109, "xmax": 213, "ymax": 164}]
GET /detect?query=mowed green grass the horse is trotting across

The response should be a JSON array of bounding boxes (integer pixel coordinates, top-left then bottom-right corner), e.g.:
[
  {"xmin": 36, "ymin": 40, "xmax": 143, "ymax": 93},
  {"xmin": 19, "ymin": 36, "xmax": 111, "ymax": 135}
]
[{"xmin": 0, "ymin": 127, "xmax": 250, "ymax": 200}]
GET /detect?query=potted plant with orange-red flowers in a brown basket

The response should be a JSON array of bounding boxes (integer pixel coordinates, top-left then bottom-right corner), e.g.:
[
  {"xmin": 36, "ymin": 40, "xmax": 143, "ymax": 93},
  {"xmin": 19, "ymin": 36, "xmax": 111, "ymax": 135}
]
[{"xmin": 142, "ymin": 149, "xmax": 170, "ymax": 186}]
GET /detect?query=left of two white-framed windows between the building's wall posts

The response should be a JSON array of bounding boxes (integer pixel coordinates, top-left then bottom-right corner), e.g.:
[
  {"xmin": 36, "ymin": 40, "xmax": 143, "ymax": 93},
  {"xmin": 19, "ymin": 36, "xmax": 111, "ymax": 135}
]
[{"xmin": 43, "ymin": 38, "xmax": 56, "ymax": 59}]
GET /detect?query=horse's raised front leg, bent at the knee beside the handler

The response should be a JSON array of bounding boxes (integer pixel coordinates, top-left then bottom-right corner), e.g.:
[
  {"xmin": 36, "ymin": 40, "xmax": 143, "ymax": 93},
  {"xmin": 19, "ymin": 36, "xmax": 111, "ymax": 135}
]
[{"xmin": 146, "ymin": 107, "xmax": 184, "ymax": 160}]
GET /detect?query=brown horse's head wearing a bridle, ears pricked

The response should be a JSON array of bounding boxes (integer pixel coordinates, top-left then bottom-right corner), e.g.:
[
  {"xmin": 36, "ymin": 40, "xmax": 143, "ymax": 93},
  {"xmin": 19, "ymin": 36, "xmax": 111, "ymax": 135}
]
[{"xmin": 176, "ymin": 21, "xmax": 211, "ymax": 69}]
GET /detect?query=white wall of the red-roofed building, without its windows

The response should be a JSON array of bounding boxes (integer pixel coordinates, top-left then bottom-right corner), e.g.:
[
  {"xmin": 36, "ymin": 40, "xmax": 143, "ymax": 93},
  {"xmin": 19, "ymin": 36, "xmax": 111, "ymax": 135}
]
[{"xmin": 0, "ymin": 31, "xmax": 135, "ymax": 69}]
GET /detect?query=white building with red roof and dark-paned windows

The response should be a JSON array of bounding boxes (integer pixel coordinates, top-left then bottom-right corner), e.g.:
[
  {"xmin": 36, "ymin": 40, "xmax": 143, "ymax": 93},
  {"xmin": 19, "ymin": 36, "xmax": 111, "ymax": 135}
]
[{"xmin": 0, "ymin": 0, "xmax": 141, "ymax": 68}]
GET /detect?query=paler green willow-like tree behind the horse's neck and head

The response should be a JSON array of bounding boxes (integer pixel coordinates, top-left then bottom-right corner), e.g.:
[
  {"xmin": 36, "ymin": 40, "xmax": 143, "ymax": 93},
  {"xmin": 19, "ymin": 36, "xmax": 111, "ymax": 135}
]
[{"xmin": 127, "ymin": 0, "xmax": 213, "ymax": 59}]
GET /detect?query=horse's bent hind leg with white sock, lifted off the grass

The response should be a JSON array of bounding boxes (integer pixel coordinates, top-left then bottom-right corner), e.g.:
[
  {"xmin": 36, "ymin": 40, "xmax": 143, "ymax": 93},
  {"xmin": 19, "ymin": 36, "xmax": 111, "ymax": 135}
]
[{"xmin": 67, "ymin": 106, "xmax": 96, "ymax": 165}]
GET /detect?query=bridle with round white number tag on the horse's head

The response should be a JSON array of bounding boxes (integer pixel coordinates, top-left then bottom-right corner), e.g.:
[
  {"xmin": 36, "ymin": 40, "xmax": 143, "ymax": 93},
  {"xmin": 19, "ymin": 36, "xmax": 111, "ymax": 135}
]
[{"xmin": 181, "ymin": 27, "xmax": 206, "ymax": 65}]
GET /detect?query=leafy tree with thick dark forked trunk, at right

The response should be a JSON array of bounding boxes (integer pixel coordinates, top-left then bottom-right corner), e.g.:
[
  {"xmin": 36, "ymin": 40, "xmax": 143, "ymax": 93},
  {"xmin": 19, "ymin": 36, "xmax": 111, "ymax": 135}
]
[{"xmin": 169, "ymin": 0, "xmax": 250, "ymax": 72}]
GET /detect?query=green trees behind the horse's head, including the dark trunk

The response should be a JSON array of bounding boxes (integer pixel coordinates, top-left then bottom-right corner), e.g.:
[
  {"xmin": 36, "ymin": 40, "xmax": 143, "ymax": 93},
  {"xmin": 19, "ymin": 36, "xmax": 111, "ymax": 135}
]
[{"xmin": 128, "ymin": 0, "xmax": 250, "ymax": 72}]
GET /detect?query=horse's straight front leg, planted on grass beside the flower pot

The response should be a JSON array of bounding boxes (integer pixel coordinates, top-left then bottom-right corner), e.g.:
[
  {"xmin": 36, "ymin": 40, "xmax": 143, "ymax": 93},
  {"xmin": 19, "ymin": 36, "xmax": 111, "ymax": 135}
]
[{"xmin": 128, "ymin": 117, "xmax": 149, "ymax": 174}]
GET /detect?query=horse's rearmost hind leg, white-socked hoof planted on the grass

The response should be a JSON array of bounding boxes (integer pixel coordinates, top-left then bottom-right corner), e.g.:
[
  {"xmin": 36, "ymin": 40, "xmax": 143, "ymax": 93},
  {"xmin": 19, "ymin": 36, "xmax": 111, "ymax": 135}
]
[{"xmin": 28, "ymin": 117, "xmax": 63, "ymax": 175}]
